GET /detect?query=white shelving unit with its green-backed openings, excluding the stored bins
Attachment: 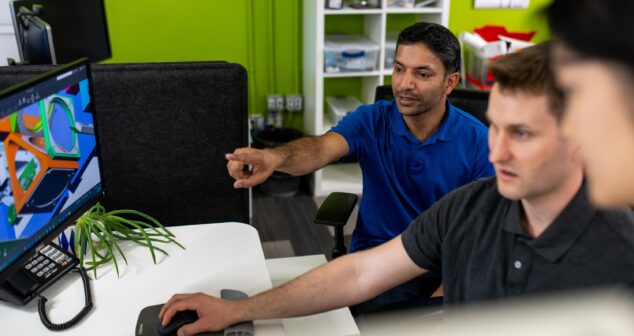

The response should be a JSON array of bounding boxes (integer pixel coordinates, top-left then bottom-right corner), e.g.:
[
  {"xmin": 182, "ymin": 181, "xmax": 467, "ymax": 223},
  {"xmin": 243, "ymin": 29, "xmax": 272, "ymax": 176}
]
[{"xmin": 303, "ymin": 0, "xmax": 450, "ymax": 196}]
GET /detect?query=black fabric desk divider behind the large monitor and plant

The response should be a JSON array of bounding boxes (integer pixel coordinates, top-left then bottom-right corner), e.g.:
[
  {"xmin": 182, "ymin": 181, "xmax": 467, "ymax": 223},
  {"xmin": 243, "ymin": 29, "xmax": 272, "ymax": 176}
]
[{"xmin": 0, "ymin": 62, "xmax": 250, "ymax": 226}]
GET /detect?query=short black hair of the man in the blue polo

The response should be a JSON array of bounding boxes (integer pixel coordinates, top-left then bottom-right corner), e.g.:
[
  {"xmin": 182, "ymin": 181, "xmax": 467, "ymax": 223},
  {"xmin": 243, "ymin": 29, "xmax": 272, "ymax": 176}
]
[{"xmin": 396, "ymin": 22, "xmax": 460, "ymax": 74}]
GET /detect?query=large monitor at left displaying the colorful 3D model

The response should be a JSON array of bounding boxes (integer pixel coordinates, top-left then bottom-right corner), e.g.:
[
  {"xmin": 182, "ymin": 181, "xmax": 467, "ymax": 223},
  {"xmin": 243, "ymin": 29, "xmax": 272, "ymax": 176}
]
[{"xmin": 0, "ymin": 61, "xmax": 102, "ymax": 280}]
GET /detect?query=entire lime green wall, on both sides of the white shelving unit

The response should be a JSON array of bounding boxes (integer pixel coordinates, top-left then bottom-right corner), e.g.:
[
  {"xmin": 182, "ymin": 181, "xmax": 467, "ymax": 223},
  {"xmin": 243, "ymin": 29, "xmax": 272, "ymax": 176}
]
[{"xmin": 100, "ymin": 0, "xmax": 551, "ymax": 128}]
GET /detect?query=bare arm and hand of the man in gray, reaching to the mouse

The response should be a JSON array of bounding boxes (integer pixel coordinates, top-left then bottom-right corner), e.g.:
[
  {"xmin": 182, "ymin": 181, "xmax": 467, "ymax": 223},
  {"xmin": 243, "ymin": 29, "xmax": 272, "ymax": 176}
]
[{"xmin": 160, "ymin": 236, "xmax": 424, "ymax": 335}]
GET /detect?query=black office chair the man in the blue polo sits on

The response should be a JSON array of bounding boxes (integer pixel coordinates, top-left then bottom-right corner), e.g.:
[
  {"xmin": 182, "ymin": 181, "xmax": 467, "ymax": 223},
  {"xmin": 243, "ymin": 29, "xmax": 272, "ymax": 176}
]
[{"xmin": 314, "ymin": 85, "xmax": 489, "ymax": 259}]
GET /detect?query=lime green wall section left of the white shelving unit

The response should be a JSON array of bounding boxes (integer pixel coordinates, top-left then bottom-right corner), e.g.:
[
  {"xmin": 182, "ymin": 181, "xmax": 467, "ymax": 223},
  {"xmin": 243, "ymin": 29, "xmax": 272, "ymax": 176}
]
[{"xmin": 105, "ymin": 0, "xmax": 302, "ymax": 129}]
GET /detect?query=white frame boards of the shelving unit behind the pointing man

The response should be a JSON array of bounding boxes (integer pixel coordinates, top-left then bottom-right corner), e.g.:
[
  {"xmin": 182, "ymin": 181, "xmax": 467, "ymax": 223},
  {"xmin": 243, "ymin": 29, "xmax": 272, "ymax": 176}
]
[{"xmin": 303, "ymin": 0, "xmax": 449, "ymax": 196}]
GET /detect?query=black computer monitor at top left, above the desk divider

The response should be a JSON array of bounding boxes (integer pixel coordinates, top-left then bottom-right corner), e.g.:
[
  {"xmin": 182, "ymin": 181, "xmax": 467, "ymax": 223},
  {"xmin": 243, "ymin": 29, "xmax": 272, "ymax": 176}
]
[{"xmin": 9, "ymin": 0, "xmax": 112, "ymax": 64}]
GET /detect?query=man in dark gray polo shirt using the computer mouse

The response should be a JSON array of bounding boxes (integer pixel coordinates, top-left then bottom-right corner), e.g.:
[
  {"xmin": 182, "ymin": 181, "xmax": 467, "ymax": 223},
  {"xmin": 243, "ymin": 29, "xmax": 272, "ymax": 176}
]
[{"xmin": 160, "ymin": 44, "xmax": 634, "ymax": 335}]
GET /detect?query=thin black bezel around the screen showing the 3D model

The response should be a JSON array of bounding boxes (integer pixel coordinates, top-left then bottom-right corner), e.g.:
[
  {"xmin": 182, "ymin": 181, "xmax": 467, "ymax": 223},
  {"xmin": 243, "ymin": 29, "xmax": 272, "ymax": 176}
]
[{"xmin": 0, "ymin": 58, "xmax": 105, "ymax": 284}]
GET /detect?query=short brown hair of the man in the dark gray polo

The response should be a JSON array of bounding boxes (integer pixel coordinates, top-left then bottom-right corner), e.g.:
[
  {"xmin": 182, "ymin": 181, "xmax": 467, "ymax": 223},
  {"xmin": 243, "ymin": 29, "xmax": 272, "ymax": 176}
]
[{"xmin": 489, "ymin": 42, "xmax": 564, "ymax": 121}]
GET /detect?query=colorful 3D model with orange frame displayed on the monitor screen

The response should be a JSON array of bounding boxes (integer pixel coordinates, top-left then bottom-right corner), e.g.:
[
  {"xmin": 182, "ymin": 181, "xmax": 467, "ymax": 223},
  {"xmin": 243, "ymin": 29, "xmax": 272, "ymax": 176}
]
[{"xmin": 0, "ymin": 81, "xmax": 95, "ymax": 241}]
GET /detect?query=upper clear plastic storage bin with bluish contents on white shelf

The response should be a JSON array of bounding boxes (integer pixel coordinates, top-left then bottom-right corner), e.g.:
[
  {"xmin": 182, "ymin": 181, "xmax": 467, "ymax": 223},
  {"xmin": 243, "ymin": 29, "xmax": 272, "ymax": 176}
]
[{"xmin": 324, "ymin": 35, "xmax": 379, "ymax": 73}]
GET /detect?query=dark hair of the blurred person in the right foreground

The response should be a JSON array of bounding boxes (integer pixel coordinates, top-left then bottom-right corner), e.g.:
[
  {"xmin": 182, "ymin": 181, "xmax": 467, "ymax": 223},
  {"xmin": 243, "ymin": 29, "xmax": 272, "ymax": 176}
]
[{"xmin": 546, "ymin": 0, "xmax": 634, "ymax": 73}]
